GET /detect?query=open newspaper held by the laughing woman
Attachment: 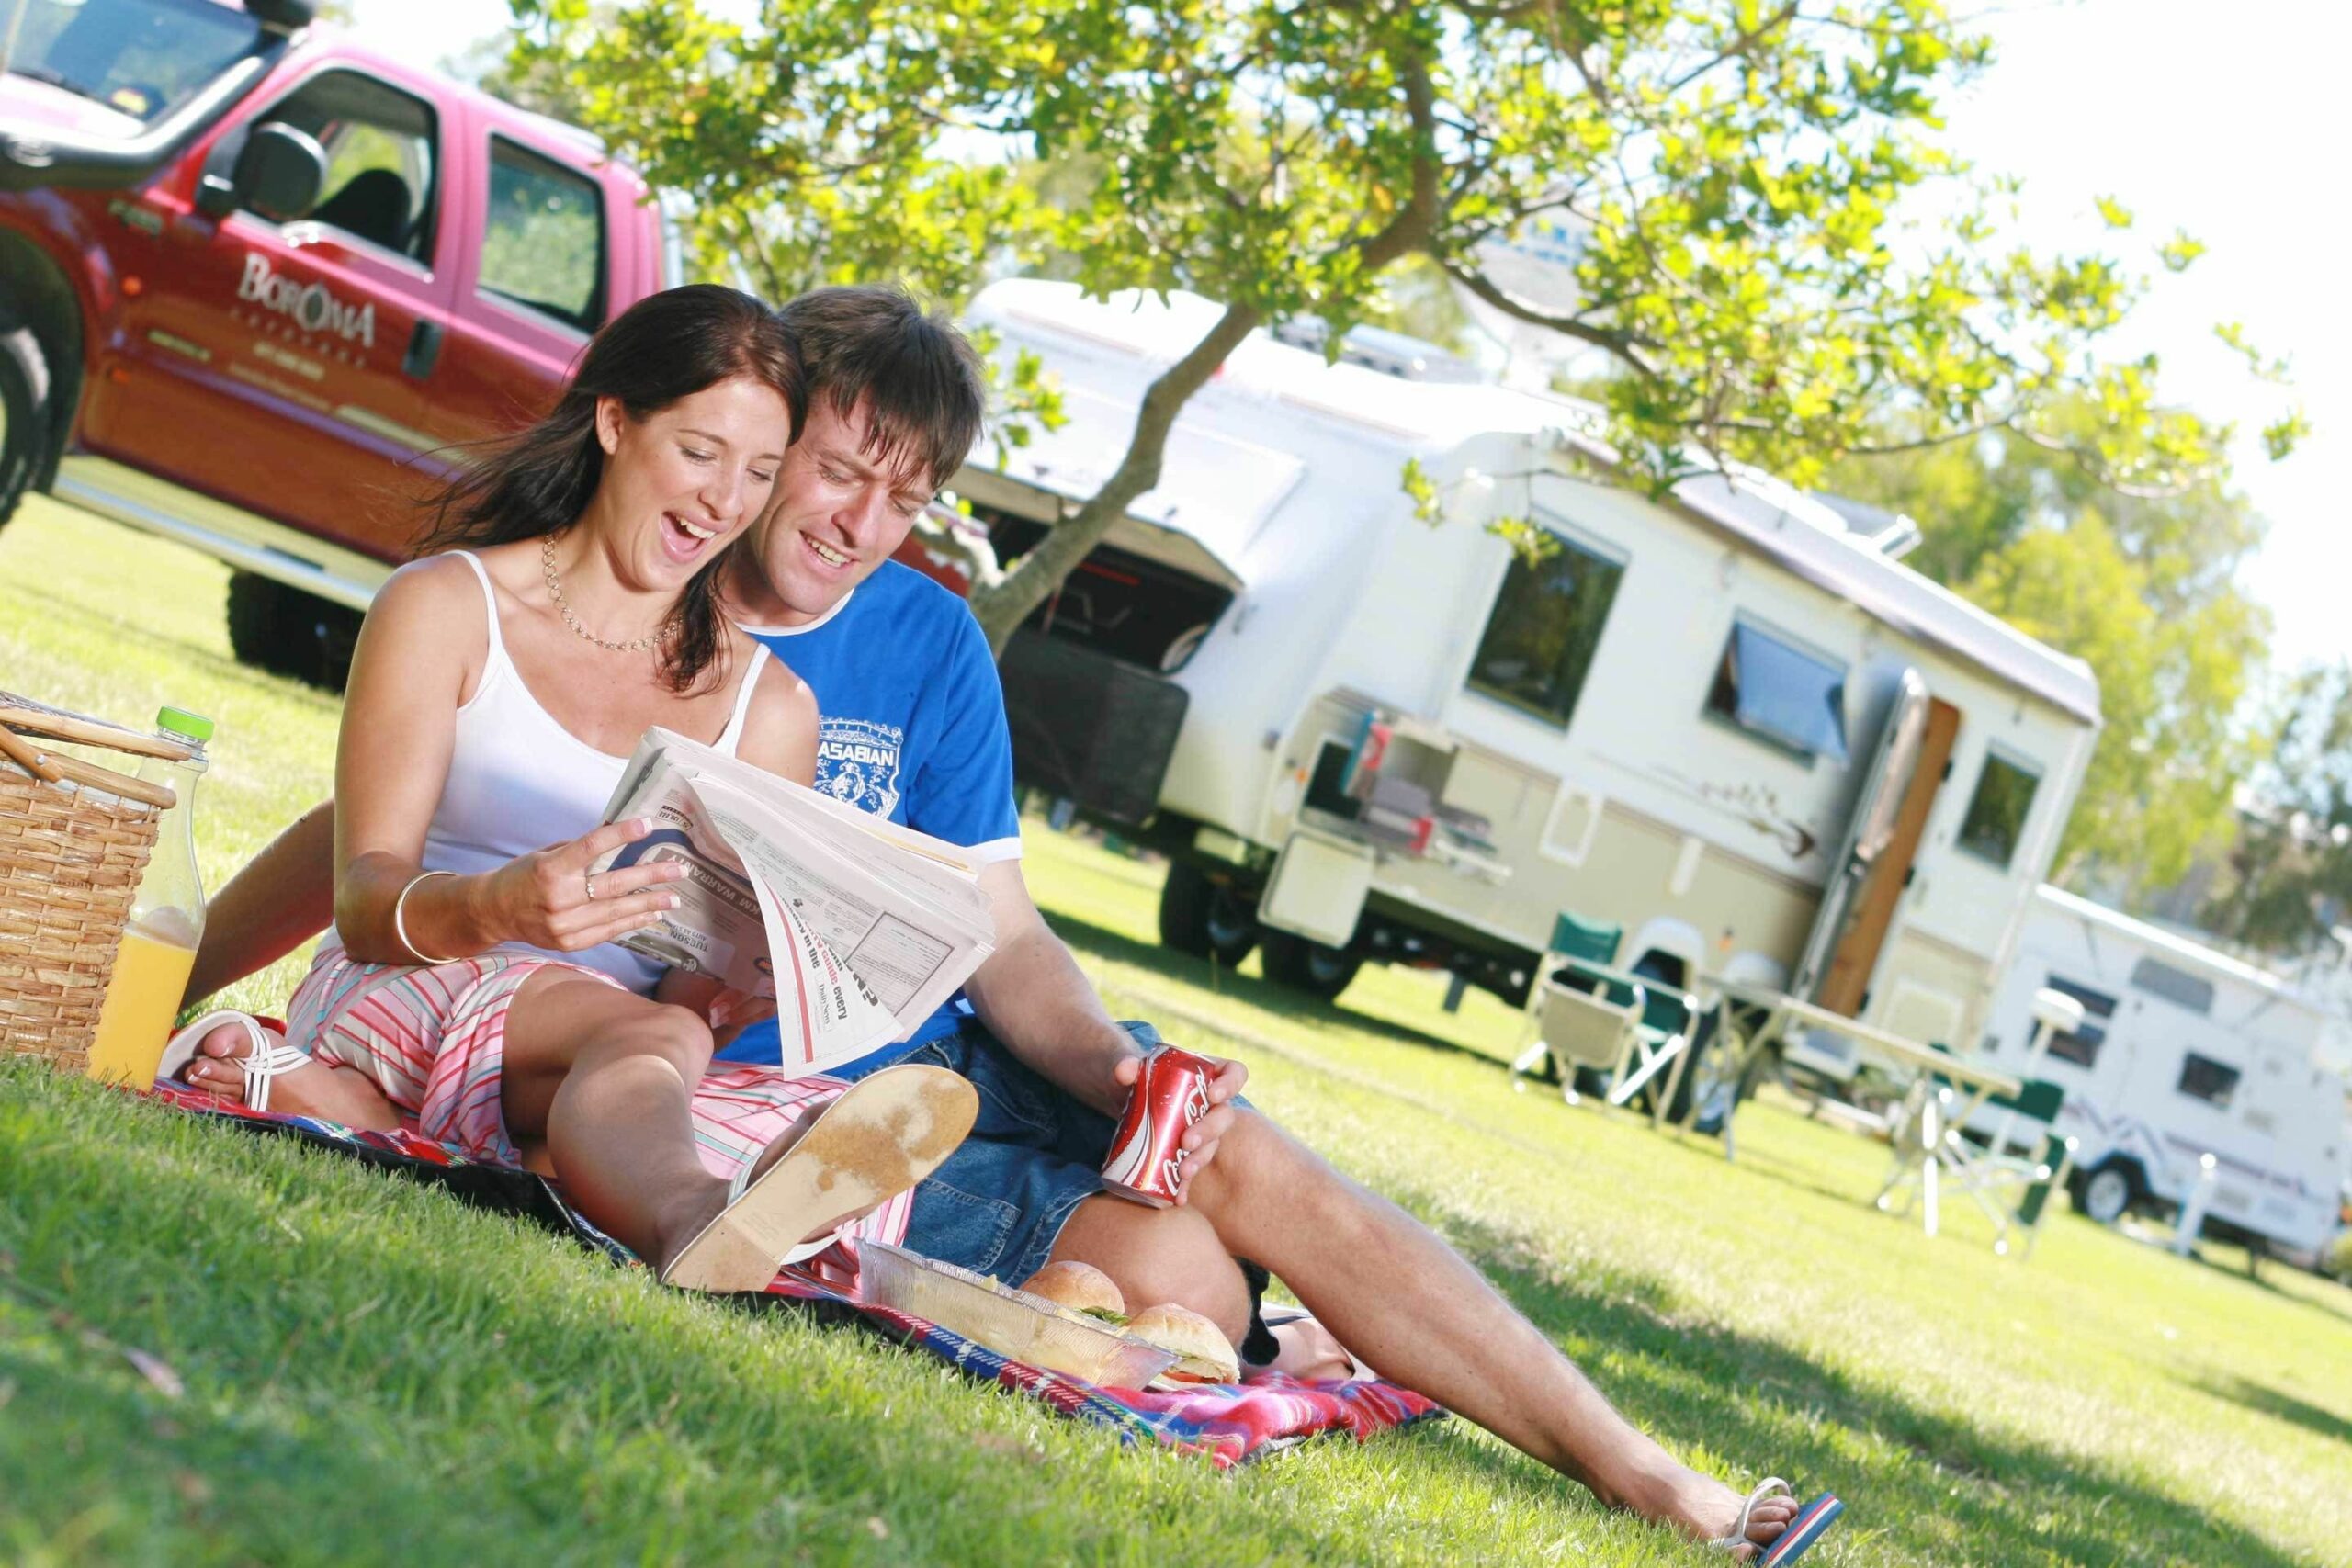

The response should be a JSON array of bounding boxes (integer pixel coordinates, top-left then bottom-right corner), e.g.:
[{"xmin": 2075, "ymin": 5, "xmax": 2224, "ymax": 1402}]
[{"xmin": 593, "ymin": 727, "xmax": 995, "ymax": 1069}]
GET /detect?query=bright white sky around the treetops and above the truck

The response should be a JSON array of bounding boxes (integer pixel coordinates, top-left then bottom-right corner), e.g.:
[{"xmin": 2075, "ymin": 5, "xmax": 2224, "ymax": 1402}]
[{"xmin": 353, "ymin": 0, "xmax": 2352, "ymax": 668}]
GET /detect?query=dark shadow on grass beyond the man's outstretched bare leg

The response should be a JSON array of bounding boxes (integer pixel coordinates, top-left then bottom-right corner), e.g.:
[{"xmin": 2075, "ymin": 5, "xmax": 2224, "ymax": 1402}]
[{"xmin": 1374, "ymin": 1194, "xmax": 2314, "ymax": 1568}]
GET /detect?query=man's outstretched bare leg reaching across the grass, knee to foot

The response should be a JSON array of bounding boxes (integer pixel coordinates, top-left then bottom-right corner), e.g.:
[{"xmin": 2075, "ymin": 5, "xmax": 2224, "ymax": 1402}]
[{"xmin": 1188, "ymin": 1112, "xmax": 1797, "ymax": 1542}]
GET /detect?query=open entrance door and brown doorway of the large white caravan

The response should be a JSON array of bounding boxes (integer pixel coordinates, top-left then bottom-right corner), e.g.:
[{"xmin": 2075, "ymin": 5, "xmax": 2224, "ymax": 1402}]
[{"xmin": 1790, "ymin": 670, "xmax": 1959, "ymax": 1018}]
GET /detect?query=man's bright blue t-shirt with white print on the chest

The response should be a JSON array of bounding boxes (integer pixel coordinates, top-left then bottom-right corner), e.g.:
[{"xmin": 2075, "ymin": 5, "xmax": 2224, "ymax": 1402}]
[{"xmin": 719, "ymin": 562, "xmax": 1021, "ymax": 1063}]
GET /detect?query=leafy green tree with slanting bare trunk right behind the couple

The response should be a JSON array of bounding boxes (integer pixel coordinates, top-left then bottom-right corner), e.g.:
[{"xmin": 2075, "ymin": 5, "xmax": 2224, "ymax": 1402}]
[{"xmin": 513, "ymin": 0, "xmax": 2296, "ymax": 647}]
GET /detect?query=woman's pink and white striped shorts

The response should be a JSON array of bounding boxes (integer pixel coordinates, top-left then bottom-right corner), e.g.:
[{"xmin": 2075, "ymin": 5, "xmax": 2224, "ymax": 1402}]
[{"xmin": 287, "ymin": 947, "xmax": 915, "ymax": 1244}]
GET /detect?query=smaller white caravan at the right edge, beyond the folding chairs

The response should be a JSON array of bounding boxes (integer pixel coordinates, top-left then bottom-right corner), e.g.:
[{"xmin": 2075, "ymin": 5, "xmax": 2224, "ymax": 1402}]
[{"xmin": 1975, "ymin": 886, "xmax": 2352, "ymax": 1256}]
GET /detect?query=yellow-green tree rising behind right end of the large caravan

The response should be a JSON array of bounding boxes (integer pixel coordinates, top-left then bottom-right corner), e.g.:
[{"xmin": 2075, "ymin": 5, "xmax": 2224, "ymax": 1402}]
[{"xmin": 1830, "ymin": 407, "xmax": 2269, "ymax": 896}]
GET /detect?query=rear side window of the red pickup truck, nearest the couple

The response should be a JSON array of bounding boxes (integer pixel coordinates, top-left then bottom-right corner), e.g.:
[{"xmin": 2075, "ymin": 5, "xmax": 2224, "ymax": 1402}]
[{"xmin": 475, "ymin": 136, "xmax": 605, "ymax": 332}]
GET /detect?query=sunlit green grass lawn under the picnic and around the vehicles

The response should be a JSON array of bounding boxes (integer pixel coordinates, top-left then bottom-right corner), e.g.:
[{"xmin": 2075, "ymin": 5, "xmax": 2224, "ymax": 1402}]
[{"xmin": 0, "ymin": 501, "xmax": 2352, "ymax": 1568}]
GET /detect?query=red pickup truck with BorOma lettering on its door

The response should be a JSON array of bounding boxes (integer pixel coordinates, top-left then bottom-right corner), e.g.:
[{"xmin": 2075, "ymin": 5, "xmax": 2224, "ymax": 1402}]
[{"xmin": 0, "ymin": 0, "xmax": 677, "ymax": 684}]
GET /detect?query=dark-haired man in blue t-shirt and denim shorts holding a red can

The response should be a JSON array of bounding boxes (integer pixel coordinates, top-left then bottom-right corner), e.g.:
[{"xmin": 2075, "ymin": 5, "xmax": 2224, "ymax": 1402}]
[{"xmin": 190, "ymin": 287, "xmax": 1794, "ymax": 1542}]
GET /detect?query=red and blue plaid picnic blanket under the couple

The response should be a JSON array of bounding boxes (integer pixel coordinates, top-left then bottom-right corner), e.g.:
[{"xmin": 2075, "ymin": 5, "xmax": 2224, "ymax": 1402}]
[{"xmin": 151, "ymin": 1084, "xmax": 1444, "ymax": 1470}]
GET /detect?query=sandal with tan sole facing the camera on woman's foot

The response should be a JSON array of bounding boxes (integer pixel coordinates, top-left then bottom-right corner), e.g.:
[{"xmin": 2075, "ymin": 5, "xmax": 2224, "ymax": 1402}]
[{"xmin": 661, "ymin": 1063, "xmax": 981, "ymax": 1295}]
